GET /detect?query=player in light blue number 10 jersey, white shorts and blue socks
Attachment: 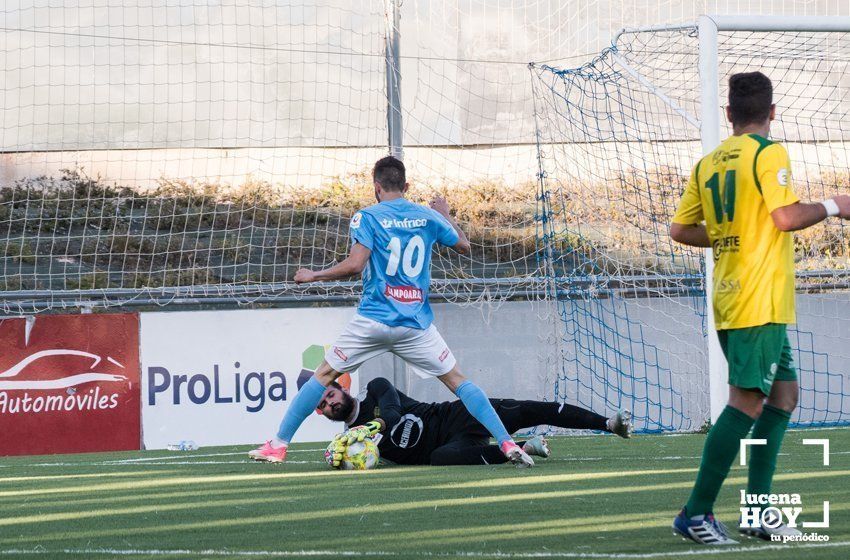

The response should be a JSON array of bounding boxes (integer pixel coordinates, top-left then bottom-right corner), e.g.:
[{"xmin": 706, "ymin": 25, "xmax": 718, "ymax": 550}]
[{"xmin": 249, "ymin": 156, "xmax": 534, "ymax": 467}]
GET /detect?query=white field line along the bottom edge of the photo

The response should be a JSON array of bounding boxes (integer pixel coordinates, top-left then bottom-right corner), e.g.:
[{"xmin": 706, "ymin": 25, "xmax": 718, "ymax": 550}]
[{"xmin": 0, "ymin": 541, "xmax": 850, "ymax": 560}]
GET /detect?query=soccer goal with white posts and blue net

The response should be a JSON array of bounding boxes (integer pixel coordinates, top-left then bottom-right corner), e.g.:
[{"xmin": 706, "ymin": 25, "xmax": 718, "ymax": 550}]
[{"xmin": 531, "ymin": 16, "xmax": 850, "ymax": 431}]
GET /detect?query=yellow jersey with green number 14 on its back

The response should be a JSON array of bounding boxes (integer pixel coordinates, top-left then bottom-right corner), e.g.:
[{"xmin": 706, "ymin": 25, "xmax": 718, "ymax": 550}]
[{"xmin": 673, "ymin": 134, "xmax": 799, "ymax": 330}]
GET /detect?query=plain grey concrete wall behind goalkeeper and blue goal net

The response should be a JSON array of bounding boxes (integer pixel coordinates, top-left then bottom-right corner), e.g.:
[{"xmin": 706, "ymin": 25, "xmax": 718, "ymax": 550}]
[{"xmin": 354, "ymin": 292, "xmax": 850, "ymax": 430}]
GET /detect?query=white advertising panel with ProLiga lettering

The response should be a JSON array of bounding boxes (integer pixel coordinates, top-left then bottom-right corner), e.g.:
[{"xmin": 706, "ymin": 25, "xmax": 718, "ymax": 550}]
[{"xmin": 141, "ymin": 308, "xmax": 358, "ymax": 449}]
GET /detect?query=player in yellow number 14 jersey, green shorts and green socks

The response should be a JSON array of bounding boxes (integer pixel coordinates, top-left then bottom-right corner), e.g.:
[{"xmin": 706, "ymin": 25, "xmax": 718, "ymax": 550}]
[{"xmin": 670, "ymin": 72, "xmax": 850, "ymax": 544}]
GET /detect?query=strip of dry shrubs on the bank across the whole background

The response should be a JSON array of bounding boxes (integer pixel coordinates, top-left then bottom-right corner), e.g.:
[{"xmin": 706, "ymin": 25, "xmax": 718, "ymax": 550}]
[{"xmin": 0, "ymin": 168, "xmax": 850, "ymax": 291}]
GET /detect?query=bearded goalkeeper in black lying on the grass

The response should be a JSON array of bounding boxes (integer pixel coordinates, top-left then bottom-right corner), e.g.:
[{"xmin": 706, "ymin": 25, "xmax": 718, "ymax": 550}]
[{"xmin": 318, "ymin": 378, "xmax": 632, "ymax": 466}]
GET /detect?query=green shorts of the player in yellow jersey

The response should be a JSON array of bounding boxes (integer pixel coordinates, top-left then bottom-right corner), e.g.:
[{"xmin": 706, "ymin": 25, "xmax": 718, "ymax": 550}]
[{"xmin": 717, "ymin": 323, "xmax": 797, "ymax": 395}]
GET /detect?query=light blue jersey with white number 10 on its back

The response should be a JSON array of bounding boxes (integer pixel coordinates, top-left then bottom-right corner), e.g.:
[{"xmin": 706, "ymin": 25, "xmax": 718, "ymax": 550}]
[{"xmin": 349, "ymin": 198, "xmax": 458, "ymax": 329}]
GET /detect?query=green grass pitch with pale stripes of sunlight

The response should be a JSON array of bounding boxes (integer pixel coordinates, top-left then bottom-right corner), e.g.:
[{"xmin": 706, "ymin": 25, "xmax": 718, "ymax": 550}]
[{"xmin": 0, "ymin": 429, "xmax": 850, "ymax": 560}]
